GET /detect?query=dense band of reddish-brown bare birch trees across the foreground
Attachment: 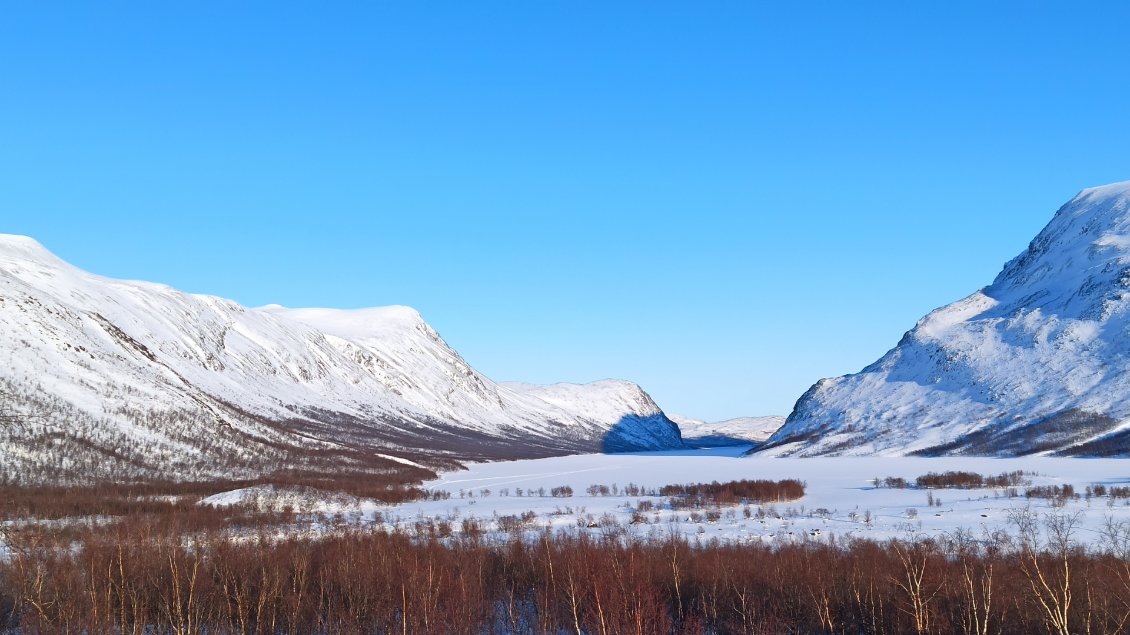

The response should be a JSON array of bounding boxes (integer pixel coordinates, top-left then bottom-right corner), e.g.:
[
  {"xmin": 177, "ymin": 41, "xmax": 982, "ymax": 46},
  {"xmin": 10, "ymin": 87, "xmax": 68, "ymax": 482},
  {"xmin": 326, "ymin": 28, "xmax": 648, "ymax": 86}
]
[{"xmin": 0, "ymin": 512, "xmax": 1130, "ymax": 635}]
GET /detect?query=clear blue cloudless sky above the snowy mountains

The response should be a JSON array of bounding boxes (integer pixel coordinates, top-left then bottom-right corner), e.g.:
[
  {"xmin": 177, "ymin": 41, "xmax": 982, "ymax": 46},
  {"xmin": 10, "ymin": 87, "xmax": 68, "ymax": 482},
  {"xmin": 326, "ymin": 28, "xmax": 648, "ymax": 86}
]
[{"xmin": 0, "ymin": 0, "xmax": 1130, "ymax": 419}]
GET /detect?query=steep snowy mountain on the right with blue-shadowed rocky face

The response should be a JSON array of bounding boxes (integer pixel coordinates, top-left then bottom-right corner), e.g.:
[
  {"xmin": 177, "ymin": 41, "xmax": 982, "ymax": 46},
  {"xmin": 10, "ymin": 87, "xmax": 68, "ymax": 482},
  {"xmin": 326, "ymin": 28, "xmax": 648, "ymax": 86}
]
[{"xmin": 766, "ymin": 182, "xmax": 1130, "ymax": 455}]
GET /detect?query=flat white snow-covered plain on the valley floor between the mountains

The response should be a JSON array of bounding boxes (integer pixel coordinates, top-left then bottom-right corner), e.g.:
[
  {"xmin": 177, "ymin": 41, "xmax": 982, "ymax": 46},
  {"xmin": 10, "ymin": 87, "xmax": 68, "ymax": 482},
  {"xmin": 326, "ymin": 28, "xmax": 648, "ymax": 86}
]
[{"xmin": 209, "ymin": 446, "xmax": 1130, "ymax": 545}]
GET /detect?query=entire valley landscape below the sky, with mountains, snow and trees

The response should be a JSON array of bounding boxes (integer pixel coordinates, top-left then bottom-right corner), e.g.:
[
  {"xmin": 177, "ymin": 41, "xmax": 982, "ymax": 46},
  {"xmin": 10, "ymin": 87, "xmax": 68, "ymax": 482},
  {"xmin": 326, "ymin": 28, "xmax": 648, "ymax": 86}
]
[{"xmin": 11, "ymin": 183, "xmax": 1130, "ymax": 635}]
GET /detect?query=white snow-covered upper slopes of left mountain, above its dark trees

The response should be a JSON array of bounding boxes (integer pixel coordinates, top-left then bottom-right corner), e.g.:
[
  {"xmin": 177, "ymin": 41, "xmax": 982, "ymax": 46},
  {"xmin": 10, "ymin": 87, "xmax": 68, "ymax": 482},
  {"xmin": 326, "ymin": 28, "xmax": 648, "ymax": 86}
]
[{"xmin": 0, "ymin": 235, "xmax": 681, "ymax": 479}]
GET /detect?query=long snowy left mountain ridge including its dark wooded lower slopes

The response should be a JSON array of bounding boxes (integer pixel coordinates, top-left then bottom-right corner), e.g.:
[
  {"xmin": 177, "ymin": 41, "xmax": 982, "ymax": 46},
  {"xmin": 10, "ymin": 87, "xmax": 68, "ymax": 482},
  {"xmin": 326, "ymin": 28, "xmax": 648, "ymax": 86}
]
[{"xmin": 0, "ymin": 235, "xmax": 683, "ymax": 480}]
